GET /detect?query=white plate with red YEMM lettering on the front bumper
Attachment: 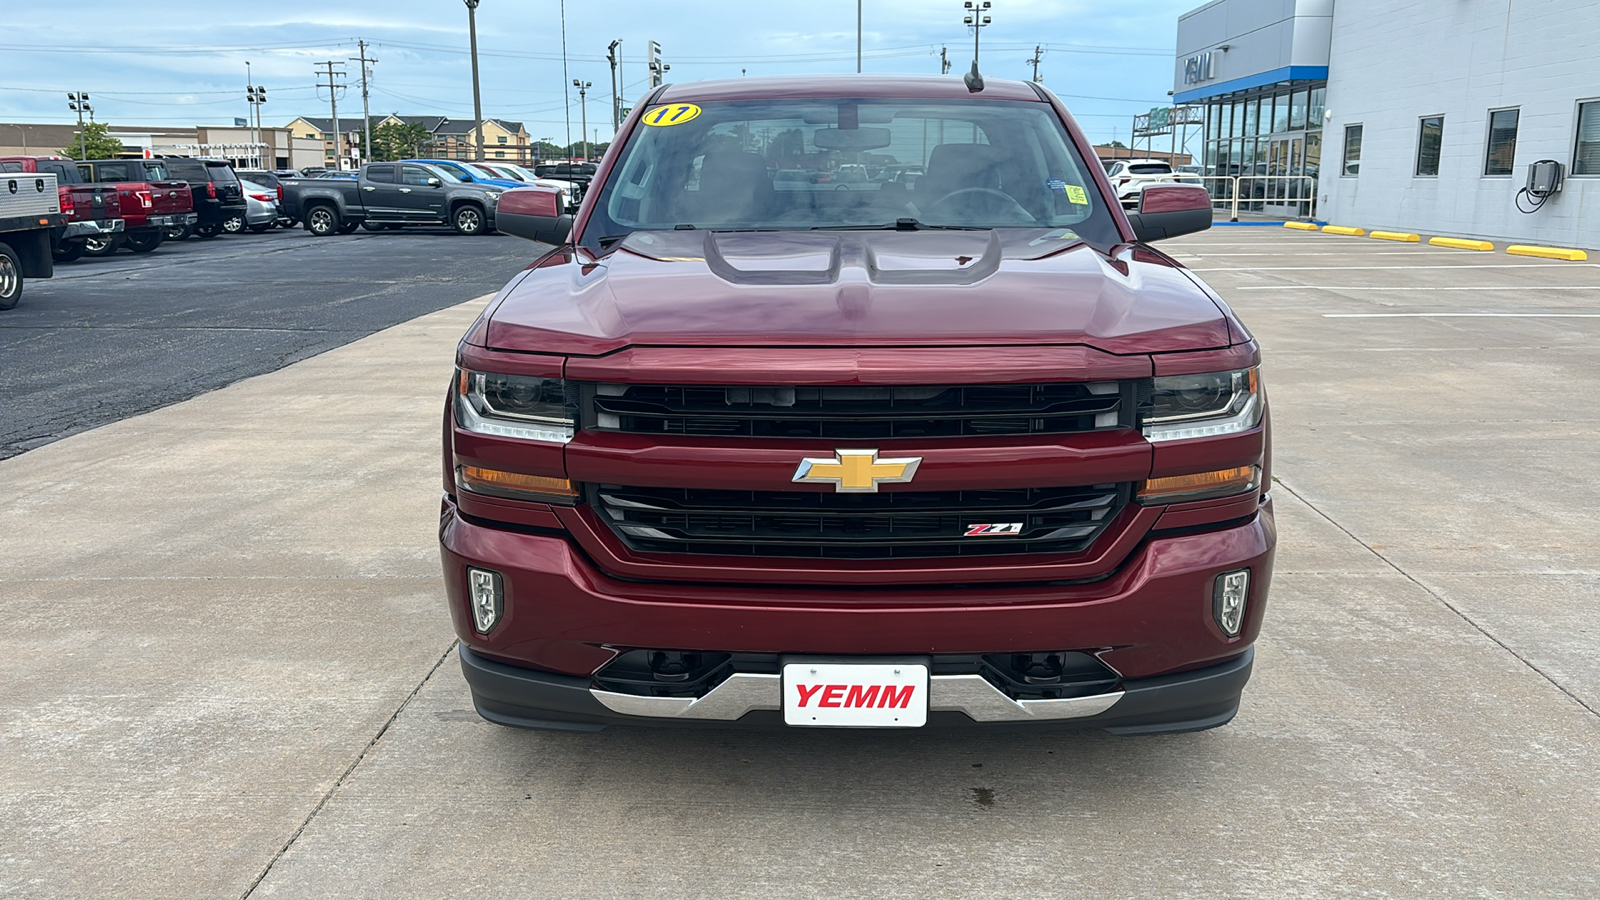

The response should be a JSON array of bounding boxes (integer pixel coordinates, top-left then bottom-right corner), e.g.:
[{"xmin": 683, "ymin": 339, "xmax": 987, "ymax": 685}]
[{"xmin": 784, "ymin": 661, "xmax": 928, "ymax": 729}]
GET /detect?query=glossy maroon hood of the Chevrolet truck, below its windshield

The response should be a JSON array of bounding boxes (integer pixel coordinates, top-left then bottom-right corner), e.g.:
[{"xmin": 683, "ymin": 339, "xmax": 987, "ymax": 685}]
[{"xmin": 474, "ymin": 229, "xmax": 1230, "ymax": 356}]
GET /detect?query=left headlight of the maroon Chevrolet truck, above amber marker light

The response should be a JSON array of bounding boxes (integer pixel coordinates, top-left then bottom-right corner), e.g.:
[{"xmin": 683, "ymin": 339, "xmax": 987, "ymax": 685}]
[{"xmin": 456, "ymin": 370, "xmax": 578, "ymax": 444}]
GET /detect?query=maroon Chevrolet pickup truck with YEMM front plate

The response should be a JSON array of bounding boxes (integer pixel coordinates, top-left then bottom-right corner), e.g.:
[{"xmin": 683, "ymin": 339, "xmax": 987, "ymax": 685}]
[{"xmin": 440, "ymin": 75, "xmax": 1275, "ymax": 733}]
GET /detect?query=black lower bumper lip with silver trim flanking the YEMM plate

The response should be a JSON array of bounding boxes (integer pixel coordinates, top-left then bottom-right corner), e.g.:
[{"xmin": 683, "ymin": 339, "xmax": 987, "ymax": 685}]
[{"xmin": 461, "ymin": 645, "xmax": 1254, "ymax": 735}]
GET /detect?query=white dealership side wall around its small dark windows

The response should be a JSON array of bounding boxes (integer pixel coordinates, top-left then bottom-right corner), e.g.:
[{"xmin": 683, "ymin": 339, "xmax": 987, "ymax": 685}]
[{"xmin": 1318, "ymin": 0, "xmax": 1600, "ymax": 248}]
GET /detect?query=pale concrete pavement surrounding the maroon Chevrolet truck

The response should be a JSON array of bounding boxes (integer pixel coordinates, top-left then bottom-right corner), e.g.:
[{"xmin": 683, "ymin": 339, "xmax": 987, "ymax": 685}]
[{"xmin": 0, "ymin": 227, "xmax": 1600, "ymax": 900}]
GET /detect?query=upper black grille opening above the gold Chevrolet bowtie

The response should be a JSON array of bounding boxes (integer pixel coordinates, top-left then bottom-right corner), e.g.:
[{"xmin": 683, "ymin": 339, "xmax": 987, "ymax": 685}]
[{"xmin": 584, "ymin": 381, "xmax": 1138, "ymax": 440}]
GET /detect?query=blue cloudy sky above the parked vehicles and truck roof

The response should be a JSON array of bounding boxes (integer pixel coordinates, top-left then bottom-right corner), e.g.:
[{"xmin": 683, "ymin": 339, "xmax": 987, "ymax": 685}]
[{"xmin": 0, "ymin": 0, "xmax": 1202, "ymax": 143}]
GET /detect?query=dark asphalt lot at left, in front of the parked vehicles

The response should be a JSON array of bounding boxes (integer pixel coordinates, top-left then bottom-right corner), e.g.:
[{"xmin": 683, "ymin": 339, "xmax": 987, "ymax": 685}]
[{"xmin": 0, "ymin": 229, "xmax": 533, "ymax": 458}]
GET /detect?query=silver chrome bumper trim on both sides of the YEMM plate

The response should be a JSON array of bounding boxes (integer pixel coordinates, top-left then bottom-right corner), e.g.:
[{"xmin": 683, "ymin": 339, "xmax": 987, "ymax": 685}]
[{"xmin": 589, "ymin": 673, "xmax": 1123, "ymax": 722}]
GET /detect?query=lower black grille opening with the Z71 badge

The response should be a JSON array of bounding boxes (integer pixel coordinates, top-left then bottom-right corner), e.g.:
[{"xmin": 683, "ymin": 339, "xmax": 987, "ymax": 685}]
[{"xmin": 587, "ymin": 484, "xmax": 1131, "ymax": 559}]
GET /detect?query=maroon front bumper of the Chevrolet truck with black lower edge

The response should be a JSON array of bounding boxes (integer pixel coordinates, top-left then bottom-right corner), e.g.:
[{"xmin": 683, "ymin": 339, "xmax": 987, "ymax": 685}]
[{"xmin": 440, "ymin": 498, "xmax": 1275, "ymax": 730}]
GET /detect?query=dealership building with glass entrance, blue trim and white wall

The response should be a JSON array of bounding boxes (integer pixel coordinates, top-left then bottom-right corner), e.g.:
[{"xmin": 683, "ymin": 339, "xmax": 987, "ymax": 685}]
[{"xmin": 1173, "ymin": 0, "xmax": 1600, "ymax": 248}]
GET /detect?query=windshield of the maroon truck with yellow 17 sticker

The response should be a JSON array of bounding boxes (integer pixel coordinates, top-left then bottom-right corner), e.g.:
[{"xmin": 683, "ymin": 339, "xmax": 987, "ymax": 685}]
[{"xmin": 582, "ymin": 99, "xmax": 1117, "ymax": 247}]
